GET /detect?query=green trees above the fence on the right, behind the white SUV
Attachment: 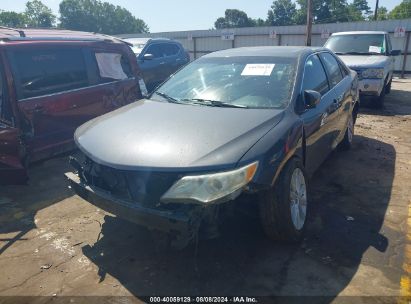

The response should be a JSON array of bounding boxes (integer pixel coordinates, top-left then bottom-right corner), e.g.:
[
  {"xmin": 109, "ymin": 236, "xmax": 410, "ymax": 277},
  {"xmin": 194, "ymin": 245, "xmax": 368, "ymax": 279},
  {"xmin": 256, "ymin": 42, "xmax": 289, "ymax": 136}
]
[{"xmin": 214, "ymin": 0, "xmax": 411, "ymax": 29}]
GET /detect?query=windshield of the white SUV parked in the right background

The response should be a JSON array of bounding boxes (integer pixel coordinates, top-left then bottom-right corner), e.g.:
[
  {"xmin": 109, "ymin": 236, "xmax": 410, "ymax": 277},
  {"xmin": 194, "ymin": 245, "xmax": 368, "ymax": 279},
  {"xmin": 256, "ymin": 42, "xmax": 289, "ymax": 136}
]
[{"xmin": 325, "ymin": 34, "xmax": 386, "ymax": 55}]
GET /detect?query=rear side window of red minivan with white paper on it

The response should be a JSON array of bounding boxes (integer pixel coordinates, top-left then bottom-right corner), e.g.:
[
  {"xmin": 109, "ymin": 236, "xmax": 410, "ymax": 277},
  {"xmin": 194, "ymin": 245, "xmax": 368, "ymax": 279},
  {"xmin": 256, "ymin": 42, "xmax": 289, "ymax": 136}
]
[{"xmin": 95, "ymin": 52, "xmax": 133, "ymax": 83}]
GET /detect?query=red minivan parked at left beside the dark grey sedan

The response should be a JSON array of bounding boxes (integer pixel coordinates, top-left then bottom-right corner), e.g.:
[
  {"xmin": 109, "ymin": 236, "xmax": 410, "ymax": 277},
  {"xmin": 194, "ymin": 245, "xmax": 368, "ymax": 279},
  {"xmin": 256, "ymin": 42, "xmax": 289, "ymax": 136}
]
[{"xmin": 0, "ymin": 27, "xmax": 143, "ymax": 184}]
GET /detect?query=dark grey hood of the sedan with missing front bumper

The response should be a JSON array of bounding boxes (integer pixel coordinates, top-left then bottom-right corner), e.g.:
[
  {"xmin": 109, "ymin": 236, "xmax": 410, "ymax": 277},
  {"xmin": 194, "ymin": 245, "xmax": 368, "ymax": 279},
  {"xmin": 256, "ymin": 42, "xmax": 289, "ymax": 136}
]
[{"xmin": 74, "ymin": 100, "xmax": 283, "ymax": 170}]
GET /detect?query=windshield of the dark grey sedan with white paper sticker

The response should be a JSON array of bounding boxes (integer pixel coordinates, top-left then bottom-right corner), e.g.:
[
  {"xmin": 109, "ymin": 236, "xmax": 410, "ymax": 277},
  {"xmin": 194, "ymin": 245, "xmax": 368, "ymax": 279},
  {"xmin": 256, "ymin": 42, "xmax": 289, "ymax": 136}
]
[{"xmin": 152, "ymin": 57, "xmax": 296, "ymax": 108}]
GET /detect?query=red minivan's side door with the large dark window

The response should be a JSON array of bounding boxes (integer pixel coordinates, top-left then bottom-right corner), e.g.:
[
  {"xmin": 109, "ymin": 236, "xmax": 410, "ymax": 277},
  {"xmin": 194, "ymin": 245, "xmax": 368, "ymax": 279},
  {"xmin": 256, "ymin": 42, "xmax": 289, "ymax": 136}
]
[{"xmin": 7, "ymin": 44, "xmax": 94, "ymax": 160}]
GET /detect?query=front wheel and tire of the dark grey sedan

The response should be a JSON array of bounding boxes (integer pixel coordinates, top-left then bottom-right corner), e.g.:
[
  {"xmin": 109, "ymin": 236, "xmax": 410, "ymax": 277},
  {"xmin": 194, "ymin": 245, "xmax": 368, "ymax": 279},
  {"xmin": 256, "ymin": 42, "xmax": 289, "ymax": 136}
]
[{"xmin": 259, "ymin": 158, "xmax": 308, "ymax": 242}]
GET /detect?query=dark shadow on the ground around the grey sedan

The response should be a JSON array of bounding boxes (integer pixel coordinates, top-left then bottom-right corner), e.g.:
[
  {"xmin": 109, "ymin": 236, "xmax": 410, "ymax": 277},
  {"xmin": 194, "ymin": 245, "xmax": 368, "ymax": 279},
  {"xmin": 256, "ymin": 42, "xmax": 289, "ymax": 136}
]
[{"xmin": 82, "ymin": 136, "xmax": 399, "ymax": 303}]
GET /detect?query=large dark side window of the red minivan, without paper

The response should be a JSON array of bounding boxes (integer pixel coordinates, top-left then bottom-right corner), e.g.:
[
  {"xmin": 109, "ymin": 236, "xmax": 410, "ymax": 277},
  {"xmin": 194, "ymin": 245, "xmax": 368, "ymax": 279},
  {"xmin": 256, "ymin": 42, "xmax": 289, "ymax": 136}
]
[{"xmin": 11, "ymin": 48, "xmax": 89, "ymax": 100}]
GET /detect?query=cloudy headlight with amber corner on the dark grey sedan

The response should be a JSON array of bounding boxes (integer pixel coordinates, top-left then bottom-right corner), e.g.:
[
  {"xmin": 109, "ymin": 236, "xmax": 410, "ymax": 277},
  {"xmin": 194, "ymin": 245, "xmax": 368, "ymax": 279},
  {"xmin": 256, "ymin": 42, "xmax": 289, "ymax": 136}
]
[{"xmin": 161, "ymin": 162, "xmax": 258, "ymax": 204}]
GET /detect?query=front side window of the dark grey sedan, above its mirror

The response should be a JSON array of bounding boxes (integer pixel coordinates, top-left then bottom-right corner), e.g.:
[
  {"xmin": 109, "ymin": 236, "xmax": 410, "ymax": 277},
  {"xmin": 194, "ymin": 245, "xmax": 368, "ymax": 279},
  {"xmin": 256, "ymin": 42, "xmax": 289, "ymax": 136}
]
[{"xmin": 303, "ymin": 55, "xmax": 329, "ymax": 95}]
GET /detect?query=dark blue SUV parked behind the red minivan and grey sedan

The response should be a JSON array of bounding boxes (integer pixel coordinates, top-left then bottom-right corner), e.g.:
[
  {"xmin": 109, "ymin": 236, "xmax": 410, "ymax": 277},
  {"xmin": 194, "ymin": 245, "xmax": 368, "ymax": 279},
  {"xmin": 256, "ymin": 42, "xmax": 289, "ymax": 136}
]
[{"xmin": 124, "ymin": 38, "xmax": 190, "ymax": 92}]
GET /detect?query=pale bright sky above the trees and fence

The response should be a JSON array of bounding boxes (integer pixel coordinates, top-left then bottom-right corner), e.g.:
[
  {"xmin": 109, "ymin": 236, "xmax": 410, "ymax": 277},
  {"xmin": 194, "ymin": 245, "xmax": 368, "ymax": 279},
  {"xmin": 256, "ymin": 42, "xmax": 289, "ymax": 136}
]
[{"xmin": 0, "ymin": 0, "xmax": 401, "ymax": 33}]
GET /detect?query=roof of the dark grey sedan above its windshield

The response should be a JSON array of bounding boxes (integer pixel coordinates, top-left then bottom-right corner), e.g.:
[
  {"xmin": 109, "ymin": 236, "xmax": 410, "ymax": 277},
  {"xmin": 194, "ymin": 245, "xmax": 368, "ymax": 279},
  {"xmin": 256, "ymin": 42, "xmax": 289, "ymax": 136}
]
[{"xmin": 203, "ymin": 46, "xmax": 329, "ymax": 58}]
